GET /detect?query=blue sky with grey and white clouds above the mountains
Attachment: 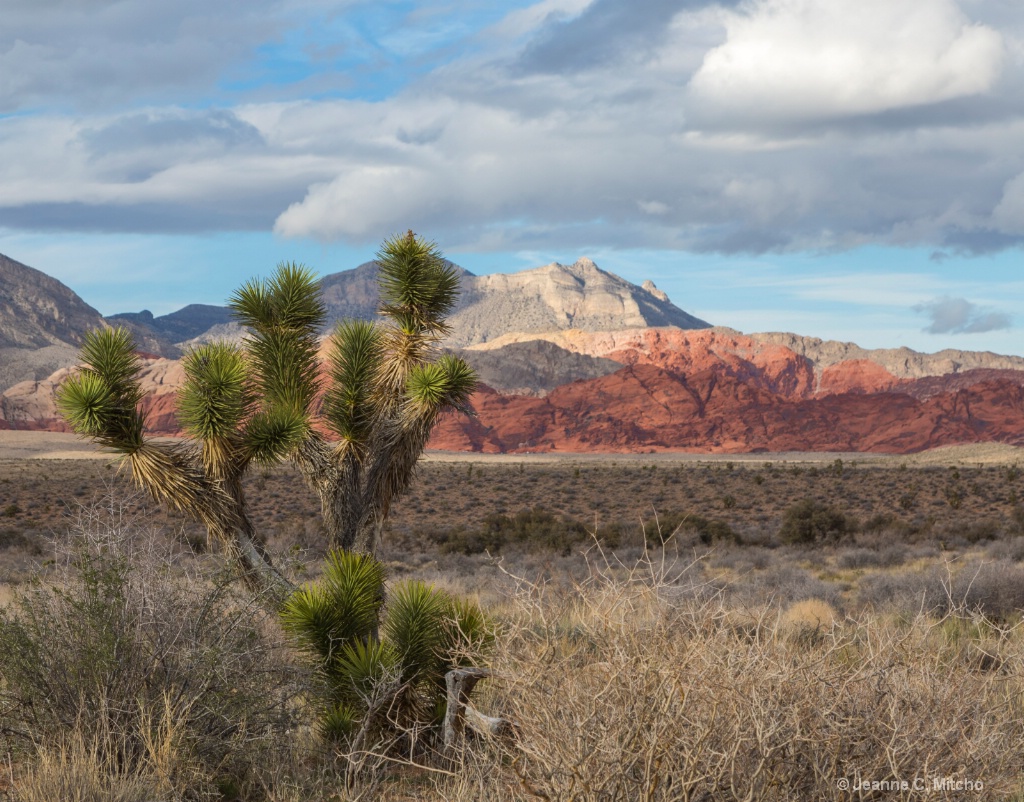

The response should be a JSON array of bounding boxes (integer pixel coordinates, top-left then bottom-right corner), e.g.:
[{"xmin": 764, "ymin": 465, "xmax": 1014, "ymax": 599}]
[{"xmin": 0, "ymin": 0, "xmax": 1024, "ymax": 354}]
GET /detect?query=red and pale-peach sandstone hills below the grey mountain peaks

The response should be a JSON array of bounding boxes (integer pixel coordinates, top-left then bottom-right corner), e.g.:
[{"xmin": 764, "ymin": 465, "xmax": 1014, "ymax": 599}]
[{"xmin": 12, "ymin": 329, "xmax": 1024, "ymax": 453}]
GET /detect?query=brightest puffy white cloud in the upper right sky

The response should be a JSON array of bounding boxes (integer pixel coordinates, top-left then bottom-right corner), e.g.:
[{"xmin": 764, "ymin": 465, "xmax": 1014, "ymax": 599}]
[{"xmin": 690, "ymin": 0, "xmax": 1004, "ymax": 120}]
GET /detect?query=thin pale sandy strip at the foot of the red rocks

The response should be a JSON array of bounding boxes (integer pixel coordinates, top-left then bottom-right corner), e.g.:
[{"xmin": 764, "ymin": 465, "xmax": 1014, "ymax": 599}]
[{"xmin": 0, "ymin": 431, "xmax": 1024, "ymax": 471}]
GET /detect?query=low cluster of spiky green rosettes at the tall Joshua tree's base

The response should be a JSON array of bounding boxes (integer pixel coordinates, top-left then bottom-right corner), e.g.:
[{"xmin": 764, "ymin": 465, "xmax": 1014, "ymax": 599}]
[{"xmin": 282, "ymin": 551, "xmax": 492, "ymax": 752}]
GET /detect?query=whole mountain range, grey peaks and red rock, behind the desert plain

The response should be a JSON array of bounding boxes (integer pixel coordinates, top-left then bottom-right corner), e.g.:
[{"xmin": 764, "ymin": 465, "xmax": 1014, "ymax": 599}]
[{"xmin": 0, "ymin": 250, "xmax": 1024, "ymax": 453}]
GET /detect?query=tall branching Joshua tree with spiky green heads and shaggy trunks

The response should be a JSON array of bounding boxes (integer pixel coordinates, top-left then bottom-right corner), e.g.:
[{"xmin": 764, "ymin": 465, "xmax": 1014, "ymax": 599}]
[{"xmin": 57, "ymin": 231, "xmax": 475, "ymax": 599}]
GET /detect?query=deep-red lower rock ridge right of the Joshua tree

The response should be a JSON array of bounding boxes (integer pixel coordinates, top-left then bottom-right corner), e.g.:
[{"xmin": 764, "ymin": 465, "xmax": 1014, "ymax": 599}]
[{"xmin": 430, "ymin": 365, "xmax": 1024, "ymax": 454}]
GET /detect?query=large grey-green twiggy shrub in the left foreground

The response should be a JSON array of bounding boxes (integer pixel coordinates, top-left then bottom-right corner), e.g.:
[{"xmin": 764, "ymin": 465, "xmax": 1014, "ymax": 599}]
[{"xmin": 0, "ymin": 502, "xmax": 298, "ymax": 798}]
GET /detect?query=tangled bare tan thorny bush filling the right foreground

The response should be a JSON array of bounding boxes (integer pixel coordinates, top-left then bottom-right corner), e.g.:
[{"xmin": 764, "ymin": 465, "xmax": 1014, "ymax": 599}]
[{"xmin": 409, "ymin": 550, "xmax": 1024, "ymax": 801}]
